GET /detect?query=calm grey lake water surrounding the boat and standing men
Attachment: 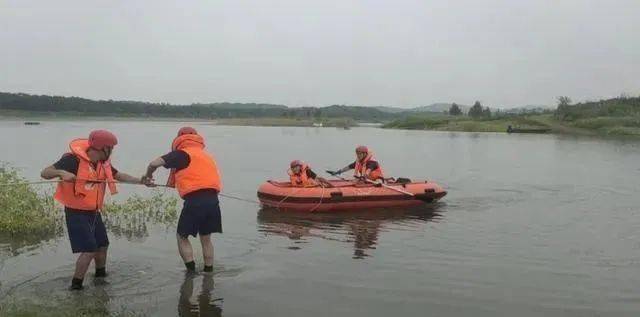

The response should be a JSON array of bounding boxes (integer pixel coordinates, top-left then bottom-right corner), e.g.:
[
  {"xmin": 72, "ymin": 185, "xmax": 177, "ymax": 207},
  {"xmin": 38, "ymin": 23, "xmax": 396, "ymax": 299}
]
[{"xmin": 0, "ymin": 121, "xmax": 640, "ymax": 317}]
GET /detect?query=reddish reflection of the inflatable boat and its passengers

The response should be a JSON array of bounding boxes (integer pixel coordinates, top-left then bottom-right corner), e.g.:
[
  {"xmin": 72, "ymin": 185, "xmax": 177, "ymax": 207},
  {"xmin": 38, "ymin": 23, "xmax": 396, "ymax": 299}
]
[{"xmin": 258, "ymin": 205, "xmax": 442, "ymax": 259}]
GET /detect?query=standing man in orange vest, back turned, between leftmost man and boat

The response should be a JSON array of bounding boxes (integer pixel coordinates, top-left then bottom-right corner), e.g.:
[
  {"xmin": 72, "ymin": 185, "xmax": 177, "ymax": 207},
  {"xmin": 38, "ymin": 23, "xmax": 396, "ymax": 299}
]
[{"xmin": 143, "ymin": 127, "xmax": 222, "ymax": 272}]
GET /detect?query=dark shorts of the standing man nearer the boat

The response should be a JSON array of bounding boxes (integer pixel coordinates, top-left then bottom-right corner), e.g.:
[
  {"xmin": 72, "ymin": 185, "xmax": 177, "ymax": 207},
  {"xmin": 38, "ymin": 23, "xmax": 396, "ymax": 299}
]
[{"xmin": 178, "ymin": 190, "xmax": 222, "ymax": 238}]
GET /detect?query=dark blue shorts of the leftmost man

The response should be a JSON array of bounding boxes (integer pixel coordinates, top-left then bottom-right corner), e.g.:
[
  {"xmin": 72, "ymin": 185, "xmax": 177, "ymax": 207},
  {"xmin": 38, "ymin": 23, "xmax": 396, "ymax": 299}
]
[{"xmin": 64, "ymin": 208, "xmax": 109, "ymax": 253}]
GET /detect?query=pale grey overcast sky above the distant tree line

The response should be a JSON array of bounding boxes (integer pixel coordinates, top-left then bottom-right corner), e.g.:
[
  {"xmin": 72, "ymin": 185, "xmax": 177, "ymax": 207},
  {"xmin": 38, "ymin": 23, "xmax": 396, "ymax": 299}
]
[{"xmin": 0, "ymin": 0, "xmax": 640, "ymax": 108}]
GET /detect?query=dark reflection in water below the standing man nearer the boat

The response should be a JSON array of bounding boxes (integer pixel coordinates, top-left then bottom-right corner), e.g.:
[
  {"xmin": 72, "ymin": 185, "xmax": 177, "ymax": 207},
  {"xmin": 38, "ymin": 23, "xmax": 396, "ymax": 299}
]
[{"xmin": 178, "ymin": 273, "xmax": 222, "ymax": 317}]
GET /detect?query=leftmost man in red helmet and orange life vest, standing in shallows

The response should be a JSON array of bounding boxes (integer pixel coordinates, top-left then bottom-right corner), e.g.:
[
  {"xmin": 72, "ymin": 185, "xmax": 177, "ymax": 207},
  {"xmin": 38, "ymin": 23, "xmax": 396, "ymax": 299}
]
[{"xmin": 41, "ymin": 130, "xmax": 141, "ymax": 290}]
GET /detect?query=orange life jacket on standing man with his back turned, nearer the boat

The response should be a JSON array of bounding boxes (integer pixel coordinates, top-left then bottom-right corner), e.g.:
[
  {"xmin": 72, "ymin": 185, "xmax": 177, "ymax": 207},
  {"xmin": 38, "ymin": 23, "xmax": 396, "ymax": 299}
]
[{"xmin": 167, "ymin": 134, "xmax": 222, "ymax": 198}]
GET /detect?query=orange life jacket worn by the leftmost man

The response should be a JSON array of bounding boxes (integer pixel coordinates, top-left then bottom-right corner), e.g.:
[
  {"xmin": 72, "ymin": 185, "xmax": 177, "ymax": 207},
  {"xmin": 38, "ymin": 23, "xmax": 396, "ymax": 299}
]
[{"xmin": 53, "ymin": 139, "xmax": 118, "ymax": 211}]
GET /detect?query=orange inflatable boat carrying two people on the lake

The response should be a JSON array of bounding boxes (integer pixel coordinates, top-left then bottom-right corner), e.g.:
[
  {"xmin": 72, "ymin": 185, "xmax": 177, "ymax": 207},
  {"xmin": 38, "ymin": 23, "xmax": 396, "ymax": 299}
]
[{"xmin": 258, "ymin": 180, "xmax": 447, "ymax": 212}]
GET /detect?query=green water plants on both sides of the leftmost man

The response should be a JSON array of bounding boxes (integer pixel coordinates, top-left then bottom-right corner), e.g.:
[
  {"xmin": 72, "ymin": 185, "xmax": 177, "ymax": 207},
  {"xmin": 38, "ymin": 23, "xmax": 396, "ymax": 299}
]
[{"xmin": 0, "ymin": 165, "xmax": 177, "ymax": 253}]
